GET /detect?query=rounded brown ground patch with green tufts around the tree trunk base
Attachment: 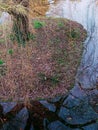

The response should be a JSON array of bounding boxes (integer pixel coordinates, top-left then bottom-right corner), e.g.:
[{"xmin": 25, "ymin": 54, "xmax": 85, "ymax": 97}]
[{"xmin": 0, "ymin": 18, "xmax": 86, "ymax": 101}]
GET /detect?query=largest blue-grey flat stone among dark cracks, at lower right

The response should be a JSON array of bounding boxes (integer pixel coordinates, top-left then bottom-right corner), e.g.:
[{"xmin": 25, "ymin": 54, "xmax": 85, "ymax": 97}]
[{"xmin": 59, "ymin": 99, "xmax": 98, "ymax": 125}]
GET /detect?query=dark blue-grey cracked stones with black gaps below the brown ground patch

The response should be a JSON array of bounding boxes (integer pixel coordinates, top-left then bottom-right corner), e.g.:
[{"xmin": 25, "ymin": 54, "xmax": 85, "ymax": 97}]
[{"xmin": 0, "ymin": 93, "xmax": 98, "ymax": 130}]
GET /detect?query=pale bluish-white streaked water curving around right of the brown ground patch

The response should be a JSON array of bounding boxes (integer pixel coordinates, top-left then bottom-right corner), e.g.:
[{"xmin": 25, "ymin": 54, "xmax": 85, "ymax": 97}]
[{"xmin": 46, "ymin": 0, "xmax": 98, "ymax": 93}]
